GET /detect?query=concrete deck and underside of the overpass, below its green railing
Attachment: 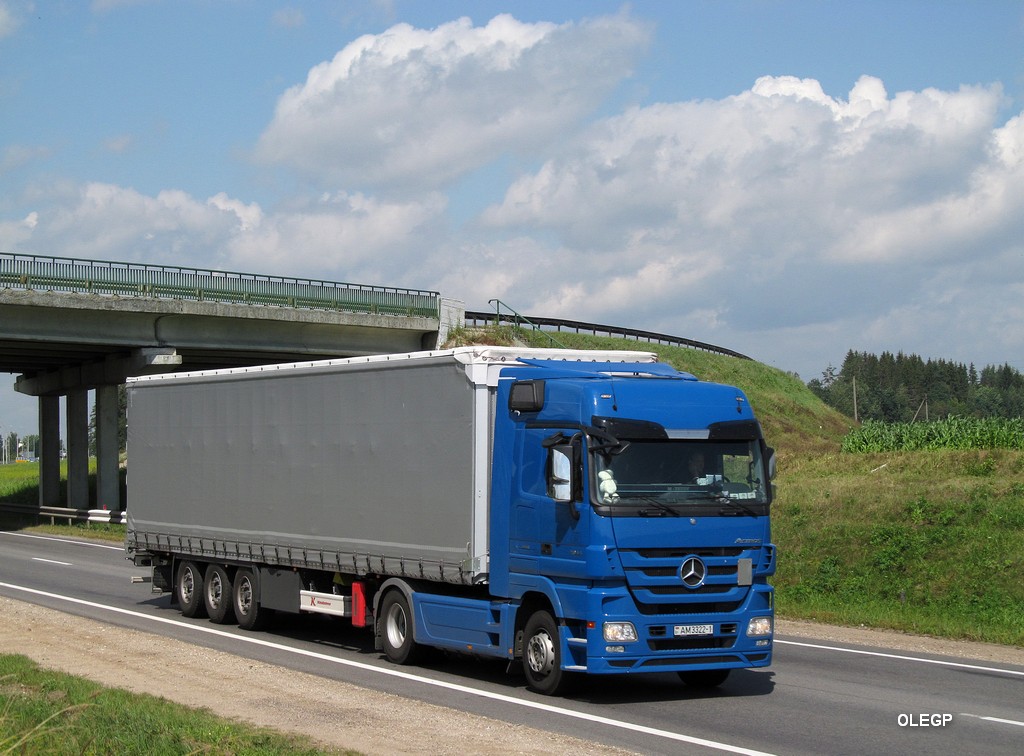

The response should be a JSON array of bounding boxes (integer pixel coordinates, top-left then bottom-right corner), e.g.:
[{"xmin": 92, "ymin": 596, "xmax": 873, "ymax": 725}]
[{"xmin": 0, "ymin": 290, "xmax": 438, "ymax": 385}]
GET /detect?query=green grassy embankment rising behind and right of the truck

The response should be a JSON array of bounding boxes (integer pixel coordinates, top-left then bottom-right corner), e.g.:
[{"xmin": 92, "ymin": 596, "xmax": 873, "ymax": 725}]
[{"xmin": 503, "ymin": 323, "xmax": 1024, "ymax": 645}]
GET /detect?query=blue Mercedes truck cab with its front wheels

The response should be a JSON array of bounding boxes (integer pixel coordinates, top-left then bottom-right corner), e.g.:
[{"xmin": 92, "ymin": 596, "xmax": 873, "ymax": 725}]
[{"xmin": 489, "ymin": 361, "xmax": 776, "ymax": 694}]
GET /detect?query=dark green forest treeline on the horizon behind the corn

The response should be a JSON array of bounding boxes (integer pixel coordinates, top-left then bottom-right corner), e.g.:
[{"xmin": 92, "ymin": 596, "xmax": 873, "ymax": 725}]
[{"xmin": 807, "ymin": 349, "xmax": 1024, "ymax": 423}]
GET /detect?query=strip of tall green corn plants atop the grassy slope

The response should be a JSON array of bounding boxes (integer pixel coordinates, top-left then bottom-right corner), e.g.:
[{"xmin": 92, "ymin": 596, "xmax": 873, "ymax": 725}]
[{"xmin": 843, "ymin": 417, "xmax": 1024, "ymax": 453}]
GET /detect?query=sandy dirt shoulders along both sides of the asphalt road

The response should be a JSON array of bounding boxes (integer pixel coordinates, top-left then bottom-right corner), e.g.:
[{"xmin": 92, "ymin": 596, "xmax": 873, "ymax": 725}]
[{"xmin": 0, "ymin": 597, "xmax": 1024, "ymax": 756}]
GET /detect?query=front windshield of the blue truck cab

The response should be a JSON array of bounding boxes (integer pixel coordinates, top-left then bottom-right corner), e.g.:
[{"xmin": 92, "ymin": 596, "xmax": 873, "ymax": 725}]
[{"xmin": 592, "ymin": 438, "xmax": 768, "ymax": 513}]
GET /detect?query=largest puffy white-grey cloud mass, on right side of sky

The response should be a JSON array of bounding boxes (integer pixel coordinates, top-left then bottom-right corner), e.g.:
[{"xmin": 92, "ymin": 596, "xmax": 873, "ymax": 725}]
[{"xmin": 473, "ymin": 71, "xmax": 1024, "ymax": 356}]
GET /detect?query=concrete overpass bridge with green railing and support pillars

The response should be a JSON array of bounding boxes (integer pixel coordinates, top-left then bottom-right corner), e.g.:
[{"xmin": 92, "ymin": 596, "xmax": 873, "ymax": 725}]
[{"xmin": 0, "ymin": 253, "xmax": 464, "ymax": 510}]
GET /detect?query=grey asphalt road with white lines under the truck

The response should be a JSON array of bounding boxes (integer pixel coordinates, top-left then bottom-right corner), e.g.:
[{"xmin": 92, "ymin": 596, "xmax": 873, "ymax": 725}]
[{"xmin": 0, "ymin": 533, "xmax": 1024, "ymax": 756}]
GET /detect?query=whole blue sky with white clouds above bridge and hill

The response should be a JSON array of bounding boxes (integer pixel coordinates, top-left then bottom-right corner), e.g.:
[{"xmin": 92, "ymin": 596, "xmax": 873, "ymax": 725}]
[{"xmin": 0, "ymin": 0, "xmax": 1024, "ymax": 433}]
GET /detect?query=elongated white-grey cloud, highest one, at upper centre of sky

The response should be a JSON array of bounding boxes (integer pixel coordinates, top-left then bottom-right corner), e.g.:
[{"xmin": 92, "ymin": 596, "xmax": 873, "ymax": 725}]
[{"xmin": 257, "ymin": 15, "xmax": 646, "ymax": 192}]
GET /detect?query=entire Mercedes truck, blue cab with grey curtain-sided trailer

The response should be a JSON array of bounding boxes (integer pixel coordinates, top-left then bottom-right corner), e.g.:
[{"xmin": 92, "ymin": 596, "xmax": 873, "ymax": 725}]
[{"xmin": 126, "ymin": 347, "xmax": 776, "ymax": 695}]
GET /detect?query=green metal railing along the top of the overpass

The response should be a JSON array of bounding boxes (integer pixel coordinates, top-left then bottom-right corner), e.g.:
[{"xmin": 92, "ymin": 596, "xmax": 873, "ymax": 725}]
[{"xmin": 0, "ymin": 252, "xmax": 440, "ymax": 318}]
